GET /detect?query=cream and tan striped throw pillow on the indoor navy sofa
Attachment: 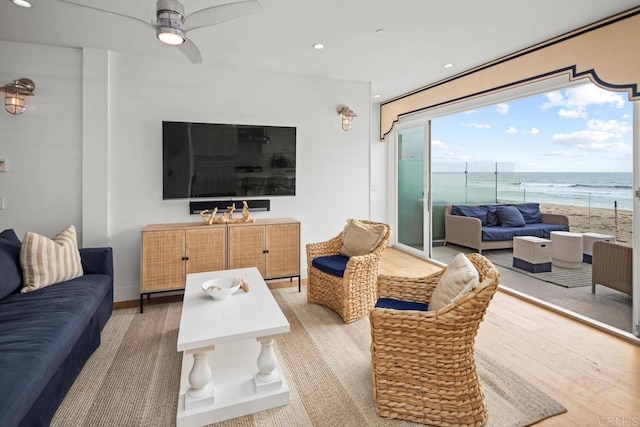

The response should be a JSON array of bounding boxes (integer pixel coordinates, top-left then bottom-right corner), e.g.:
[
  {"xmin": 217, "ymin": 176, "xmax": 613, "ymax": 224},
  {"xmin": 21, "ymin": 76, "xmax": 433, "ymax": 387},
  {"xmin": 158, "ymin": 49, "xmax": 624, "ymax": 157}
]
[{"xmin": 20, "ymin": 225, "xmax": 83, "ymax": 293}]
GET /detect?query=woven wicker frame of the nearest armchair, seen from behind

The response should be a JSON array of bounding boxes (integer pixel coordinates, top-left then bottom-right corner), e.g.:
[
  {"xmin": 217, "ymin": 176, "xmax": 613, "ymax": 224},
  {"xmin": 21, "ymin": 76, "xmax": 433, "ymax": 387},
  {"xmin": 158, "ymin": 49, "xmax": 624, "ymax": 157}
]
[{"xmin": 369, "ymin": 253, "xmax": 500, "ymax": 426}]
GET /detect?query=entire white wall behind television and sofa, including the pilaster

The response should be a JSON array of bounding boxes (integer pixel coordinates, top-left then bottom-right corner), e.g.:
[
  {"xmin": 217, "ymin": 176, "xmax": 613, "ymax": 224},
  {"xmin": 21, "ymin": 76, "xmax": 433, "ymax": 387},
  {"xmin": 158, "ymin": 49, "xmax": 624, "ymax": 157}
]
[{"xmin": 0, "ymin": 42, "xmax": 380, "ymax": 301}]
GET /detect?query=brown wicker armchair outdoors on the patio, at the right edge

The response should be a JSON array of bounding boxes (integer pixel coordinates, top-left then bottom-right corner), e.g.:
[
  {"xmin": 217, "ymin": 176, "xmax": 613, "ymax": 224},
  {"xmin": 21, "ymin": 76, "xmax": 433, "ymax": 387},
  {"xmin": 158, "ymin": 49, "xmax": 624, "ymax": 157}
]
[{"xmin": 591, "ymin": 241, "xmax": 633, "ymax": 296}]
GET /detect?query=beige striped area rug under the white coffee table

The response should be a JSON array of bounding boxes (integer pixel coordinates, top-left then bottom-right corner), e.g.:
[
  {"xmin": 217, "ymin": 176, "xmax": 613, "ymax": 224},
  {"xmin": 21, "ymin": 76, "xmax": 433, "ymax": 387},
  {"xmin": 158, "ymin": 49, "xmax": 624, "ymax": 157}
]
[{"xmin": 52, "ymin": 288, "xmax": 566, "ymax": 427}]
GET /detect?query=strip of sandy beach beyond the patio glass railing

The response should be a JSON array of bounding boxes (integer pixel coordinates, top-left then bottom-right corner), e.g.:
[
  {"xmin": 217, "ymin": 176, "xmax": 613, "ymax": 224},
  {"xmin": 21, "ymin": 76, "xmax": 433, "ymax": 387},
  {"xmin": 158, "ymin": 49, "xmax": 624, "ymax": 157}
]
[{"xmin": 540, "ymin": 203, "xmax": 633, "ymax": 246}]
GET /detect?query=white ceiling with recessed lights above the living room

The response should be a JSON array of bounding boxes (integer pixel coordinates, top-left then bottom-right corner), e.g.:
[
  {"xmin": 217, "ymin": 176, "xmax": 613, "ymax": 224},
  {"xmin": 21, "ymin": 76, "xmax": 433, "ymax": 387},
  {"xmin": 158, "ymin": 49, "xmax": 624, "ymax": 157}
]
[{"xmin": 0, "ymin": 0, "xmax": 640, "ymax": 100}]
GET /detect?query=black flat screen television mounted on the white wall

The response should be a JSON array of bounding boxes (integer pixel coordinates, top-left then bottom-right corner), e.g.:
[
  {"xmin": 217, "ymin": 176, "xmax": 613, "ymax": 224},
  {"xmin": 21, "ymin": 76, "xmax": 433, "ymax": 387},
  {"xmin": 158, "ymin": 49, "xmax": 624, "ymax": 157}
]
[{"xmin": 162, "ymin": 121, "xmax": 296, "ymax": 200}]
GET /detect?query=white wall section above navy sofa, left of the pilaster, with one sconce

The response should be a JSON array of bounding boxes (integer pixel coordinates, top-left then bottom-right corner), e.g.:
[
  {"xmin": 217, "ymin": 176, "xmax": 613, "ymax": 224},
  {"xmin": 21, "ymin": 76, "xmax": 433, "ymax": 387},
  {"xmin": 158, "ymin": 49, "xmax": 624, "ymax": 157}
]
[{"xmin": 0, "ymin": 41, "xmax": 82, "ymax": 242}]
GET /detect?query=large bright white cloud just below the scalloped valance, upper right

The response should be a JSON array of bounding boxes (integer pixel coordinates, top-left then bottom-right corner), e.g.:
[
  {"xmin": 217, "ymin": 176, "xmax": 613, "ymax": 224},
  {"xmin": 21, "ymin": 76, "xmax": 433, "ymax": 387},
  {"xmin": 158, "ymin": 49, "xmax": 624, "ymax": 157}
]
[{"xmin": 540, "ymin": 84, "xmax": 624, "ymax": 119}]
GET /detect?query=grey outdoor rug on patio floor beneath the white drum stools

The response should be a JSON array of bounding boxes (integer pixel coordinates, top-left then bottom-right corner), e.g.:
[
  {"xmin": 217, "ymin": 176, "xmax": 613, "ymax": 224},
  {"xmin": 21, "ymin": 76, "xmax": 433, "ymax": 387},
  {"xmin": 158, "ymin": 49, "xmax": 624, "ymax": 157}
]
[{"xmin": 482, "ymin": 249, "xmax": 591, "ymax": 288}]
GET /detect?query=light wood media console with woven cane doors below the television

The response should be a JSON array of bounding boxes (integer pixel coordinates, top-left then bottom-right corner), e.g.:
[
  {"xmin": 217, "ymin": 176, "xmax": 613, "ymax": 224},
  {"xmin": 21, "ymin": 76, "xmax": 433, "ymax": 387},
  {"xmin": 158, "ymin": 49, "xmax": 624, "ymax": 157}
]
[{"xmin": 140, "ymin": 218, "xmax": 300, "ymax": 313}]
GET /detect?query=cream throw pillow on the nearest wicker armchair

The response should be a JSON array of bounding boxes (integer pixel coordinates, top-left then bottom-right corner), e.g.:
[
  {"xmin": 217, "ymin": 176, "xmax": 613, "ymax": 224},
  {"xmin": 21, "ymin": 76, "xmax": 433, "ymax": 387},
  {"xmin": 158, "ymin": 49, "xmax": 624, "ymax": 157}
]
[{"xmin": 429, "ymin": 253, "xmax": 480, "ymax": 311}]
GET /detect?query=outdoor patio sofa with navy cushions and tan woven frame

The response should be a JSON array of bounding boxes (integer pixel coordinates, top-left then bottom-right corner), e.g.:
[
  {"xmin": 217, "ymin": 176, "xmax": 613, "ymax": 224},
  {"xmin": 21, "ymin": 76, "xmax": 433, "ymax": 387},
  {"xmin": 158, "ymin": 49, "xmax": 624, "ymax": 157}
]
[{"xmin": 444, "ymin": 203, "xmax": 569, "ymax": 253}]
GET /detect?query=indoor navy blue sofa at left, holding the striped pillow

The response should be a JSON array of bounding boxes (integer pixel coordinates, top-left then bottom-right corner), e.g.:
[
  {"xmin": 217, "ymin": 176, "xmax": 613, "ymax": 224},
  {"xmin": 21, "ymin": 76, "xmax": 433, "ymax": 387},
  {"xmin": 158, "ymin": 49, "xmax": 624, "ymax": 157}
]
[{"xmin": 0, "ymin": 230, "xmax": 113, "ymax": 427}]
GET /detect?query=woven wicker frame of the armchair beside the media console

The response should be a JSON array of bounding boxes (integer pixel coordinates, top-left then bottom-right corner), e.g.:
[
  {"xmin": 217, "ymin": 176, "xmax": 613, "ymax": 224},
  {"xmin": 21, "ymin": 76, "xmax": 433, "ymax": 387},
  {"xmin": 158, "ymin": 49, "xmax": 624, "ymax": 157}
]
[{"xmin": 307, "ymin": 221, "xmax": 391, "ymax": 323}]
